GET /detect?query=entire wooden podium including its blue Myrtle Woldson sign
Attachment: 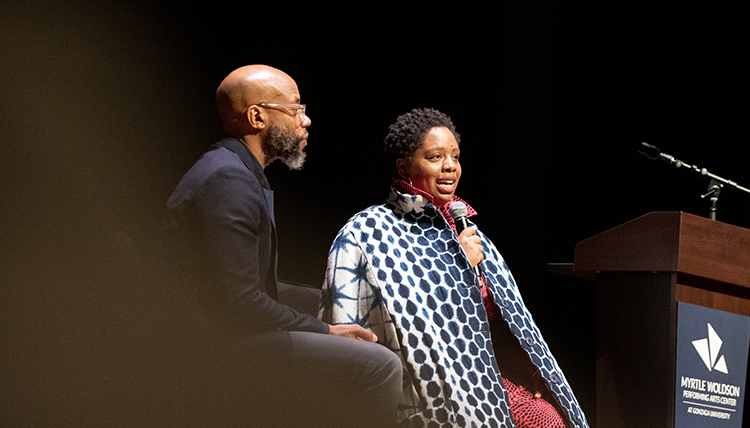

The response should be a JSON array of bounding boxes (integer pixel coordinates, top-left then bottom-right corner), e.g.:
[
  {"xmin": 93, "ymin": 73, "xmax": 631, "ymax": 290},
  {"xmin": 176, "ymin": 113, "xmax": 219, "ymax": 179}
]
[{"xmin": 573, "ymin": 212, "xmax": 750, "ymax": 428}]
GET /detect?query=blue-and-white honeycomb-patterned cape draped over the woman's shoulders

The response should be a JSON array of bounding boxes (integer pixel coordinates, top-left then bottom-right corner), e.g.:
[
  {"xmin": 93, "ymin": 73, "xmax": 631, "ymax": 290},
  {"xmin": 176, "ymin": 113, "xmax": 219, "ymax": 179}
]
[{"xmin": 319, "ymin": 189, "xmax": 588, "ymax": 427}]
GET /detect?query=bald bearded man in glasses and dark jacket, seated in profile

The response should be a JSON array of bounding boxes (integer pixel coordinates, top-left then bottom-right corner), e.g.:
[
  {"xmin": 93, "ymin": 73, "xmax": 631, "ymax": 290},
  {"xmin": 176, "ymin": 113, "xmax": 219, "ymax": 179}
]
[{"xmin": 167, "ymin": 65, "xmax": 401, "ymax": 427}]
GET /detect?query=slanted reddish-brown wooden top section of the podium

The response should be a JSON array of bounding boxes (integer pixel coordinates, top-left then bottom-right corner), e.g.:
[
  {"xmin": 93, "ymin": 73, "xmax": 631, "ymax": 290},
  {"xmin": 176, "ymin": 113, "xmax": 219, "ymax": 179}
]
[{"xmin": 573, "ymin": 211, "xmax": 750, "ymax": 288}]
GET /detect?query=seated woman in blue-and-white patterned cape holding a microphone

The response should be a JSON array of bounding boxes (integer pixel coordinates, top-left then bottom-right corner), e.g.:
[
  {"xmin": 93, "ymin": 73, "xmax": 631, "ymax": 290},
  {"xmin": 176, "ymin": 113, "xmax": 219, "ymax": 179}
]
[{"xmin": 320, "ymin": 109, "xmax": 588, "ymax": 427}]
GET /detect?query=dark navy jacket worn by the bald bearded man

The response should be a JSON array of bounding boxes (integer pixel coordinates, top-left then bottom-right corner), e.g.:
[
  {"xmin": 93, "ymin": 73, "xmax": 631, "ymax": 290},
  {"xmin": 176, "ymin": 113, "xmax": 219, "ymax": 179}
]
[{"xmin": 167, "ymin": 138, "xmax": 329, "ymax": 334}]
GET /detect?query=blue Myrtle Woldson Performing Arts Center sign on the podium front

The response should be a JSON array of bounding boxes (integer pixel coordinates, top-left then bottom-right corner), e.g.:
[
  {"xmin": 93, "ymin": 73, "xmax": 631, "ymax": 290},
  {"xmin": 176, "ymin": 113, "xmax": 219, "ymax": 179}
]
[{"xmin": 675, "ymin": 302, "xmax": 750, "ymax": 428}]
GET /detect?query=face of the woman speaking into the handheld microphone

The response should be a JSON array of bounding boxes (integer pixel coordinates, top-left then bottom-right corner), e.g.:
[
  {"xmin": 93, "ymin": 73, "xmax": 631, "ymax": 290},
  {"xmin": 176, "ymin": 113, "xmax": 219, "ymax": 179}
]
[{"xmin": 396, "ymin": 126, "xmax": 461, "ymax": 208}]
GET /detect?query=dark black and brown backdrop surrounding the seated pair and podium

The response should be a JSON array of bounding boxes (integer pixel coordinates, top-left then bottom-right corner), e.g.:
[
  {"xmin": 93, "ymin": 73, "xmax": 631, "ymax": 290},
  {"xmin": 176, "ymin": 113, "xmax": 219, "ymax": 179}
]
[{"xmin": 0, "ymin": 0, "xmax": 750, "ymax": 427}]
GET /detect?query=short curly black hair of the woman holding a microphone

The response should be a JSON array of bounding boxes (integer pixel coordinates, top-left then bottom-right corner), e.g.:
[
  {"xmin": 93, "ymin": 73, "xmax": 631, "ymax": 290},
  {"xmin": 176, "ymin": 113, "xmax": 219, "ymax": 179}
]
[{"xmin": 384, "ymin": 108, "xmax": 461, "ymax": 177}]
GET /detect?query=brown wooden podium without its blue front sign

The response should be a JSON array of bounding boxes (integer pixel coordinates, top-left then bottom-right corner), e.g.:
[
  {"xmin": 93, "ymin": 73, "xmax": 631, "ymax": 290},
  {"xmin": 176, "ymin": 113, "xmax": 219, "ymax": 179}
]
[{"xmin": 571, "ymin": 212, "xmax": 750, "ymax": 428}]
